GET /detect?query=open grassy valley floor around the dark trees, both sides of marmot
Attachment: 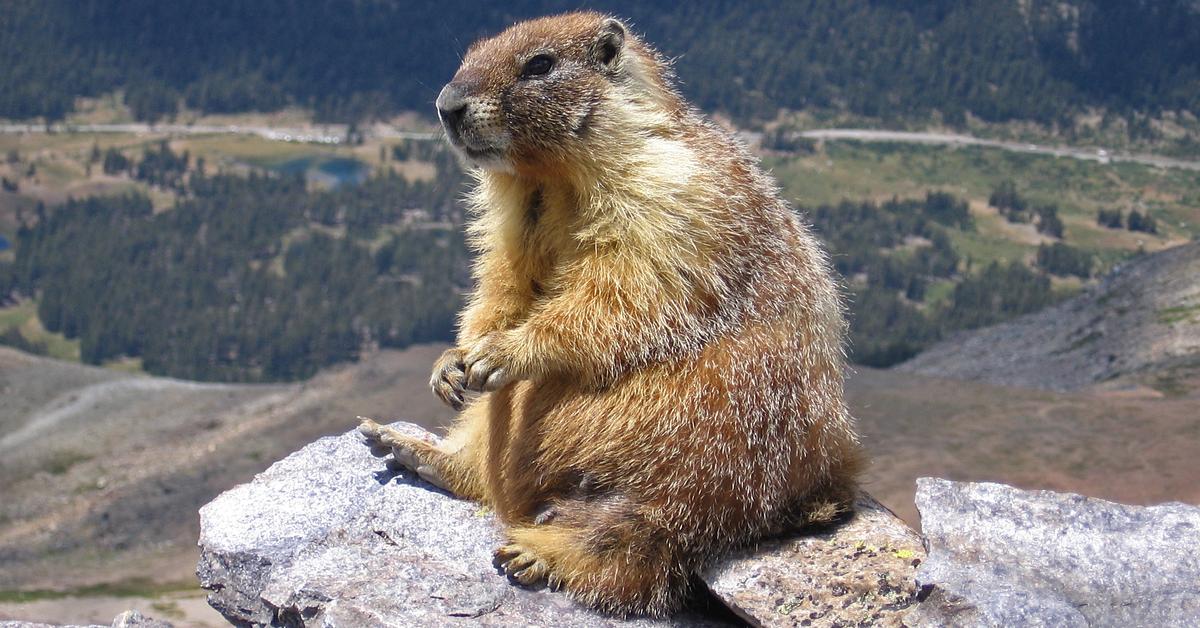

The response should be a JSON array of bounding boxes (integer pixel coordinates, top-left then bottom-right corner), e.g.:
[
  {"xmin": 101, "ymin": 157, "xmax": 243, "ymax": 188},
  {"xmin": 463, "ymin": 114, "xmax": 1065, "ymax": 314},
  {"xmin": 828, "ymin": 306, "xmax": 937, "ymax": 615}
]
[{"xmin": 0, "ymin": 106, "xmax": 1200, "ymax": 377}]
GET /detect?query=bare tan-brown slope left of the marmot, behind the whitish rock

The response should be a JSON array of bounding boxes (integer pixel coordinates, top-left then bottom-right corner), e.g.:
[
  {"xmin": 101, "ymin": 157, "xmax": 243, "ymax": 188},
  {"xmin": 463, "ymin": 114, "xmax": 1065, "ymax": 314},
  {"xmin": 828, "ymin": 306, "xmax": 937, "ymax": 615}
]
[{"xmin": 0, "ymin": 346, "xmax": 450, "ymax": 591}]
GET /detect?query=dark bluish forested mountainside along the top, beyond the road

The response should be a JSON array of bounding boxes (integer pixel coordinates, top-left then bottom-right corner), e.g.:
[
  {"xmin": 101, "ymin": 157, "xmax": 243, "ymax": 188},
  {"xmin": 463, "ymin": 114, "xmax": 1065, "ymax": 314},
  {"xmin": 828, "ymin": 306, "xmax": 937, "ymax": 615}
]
[{"xmin": 0, "ymin": 0, "xmax": 1200, "ymax": 122}]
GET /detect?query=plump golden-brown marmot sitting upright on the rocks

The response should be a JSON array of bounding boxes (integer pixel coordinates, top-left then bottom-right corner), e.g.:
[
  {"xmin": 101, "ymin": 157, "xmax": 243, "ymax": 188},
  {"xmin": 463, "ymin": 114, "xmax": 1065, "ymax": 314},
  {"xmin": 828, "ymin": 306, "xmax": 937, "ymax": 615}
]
[{"xmin": 362, "ymin": 12, "xmax": 863, "ymax": 616}]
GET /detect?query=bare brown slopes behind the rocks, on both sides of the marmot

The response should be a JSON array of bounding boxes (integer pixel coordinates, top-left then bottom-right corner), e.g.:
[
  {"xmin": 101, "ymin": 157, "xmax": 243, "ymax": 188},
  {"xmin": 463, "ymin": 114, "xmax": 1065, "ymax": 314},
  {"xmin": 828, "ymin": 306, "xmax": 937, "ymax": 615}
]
[{"xmin": 0, "ymin": 333, "xmax": 1200, "ymax": 621}]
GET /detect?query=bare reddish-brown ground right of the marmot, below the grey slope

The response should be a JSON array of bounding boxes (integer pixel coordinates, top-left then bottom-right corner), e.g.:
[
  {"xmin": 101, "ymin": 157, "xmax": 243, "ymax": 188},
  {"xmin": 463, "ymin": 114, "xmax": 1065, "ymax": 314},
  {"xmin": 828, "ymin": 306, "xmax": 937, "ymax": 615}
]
[{"xmin": 848, "ymin": 369, "xmax": 1200, "ymax": 525}]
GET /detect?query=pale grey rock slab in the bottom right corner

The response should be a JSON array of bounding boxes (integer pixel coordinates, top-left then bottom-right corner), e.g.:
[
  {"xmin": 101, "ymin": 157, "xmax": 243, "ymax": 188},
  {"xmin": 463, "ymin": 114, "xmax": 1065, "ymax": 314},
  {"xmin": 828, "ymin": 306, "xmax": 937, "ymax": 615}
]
[{"xmin": 906, "ymin": 478, "xmax": 1200, "ymax": 627}]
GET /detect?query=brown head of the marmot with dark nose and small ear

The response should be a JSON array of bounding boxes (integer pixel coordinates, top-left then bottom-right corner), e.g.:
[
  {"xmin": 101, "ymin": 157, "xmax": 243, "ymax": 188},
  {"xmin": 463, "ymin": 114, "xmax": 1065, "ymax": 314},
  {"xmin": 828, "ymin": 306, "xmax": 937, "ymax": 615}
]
[{"xmin": 437, "ymin": 12, "xmax": 684, "ymax": 172}]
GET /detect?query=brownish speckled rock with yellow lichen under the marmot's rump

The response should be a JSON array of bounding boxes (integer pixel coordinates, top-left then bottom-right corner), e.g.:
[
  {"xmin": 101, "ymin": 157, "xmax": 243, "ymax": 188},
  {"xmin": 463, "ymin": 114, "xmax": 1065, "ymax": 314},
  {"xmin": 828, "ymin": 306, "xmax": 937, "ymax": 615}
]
[{"xmin": 703, "ymin": 494, "xmax": 925, "ymax": 626}]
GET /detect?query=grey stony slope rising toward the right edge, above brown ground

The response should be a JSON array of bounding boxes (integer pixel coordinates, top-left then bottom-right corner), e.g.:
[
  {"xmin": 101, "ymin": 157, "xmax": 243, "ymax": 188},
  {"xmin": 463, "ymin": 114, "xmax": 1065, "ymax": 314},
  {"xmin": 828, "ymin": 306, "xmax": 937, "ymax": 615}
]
[{"xmin": 896, "ymin": 243, "xmax": 1200, "ymax": 390}]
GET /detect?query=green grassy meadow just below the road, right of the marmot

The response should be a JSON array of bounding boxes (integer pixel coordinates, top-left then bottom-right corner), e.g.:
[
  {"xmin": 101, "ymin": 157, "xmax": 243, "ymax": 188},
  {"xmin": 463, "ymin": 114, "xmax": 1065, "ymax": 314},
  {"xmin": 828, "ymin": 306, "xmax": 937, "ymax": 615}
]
[{"xmin": 764, "ymin": 142, "xmax": 1200, "ymax": 262}]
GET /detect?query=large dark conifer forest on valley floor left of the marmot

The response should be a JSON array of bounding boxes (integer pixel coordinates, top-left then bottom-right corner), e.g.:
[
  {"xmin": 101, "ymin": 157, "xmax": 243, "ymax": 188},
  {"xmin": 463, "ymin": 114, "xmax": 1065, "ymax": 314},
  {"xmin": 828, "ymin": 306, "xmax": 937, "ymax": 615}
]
[{"xmin": 0, "ymin": 146, "xmax": 469, "ymax": 382}]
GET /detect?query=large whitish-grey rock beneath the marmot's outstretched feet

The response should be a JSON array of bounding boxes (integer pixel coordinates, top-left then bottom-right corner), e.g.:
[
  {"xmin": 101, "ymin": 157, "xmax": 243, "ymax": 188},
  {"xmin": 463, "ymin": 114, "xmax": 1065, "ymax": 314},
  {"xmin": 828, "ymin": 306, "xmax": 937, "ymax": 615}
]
[{"xmin": 197, "ymin": 423, "xmax": 698, "ymax": 627}]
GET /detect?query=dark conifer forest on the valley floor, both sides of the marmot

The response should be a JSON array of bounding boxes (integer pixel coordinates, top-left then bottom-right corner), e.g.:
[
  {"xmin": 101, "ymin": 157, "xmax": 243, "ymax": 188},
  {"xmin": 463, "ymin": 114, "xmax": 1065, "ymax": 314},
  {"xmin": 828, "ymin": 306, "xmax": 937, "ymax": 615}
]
[{"xmin": 0, "ymin": 137, "xmax": 1075, "ymax": 382}]
